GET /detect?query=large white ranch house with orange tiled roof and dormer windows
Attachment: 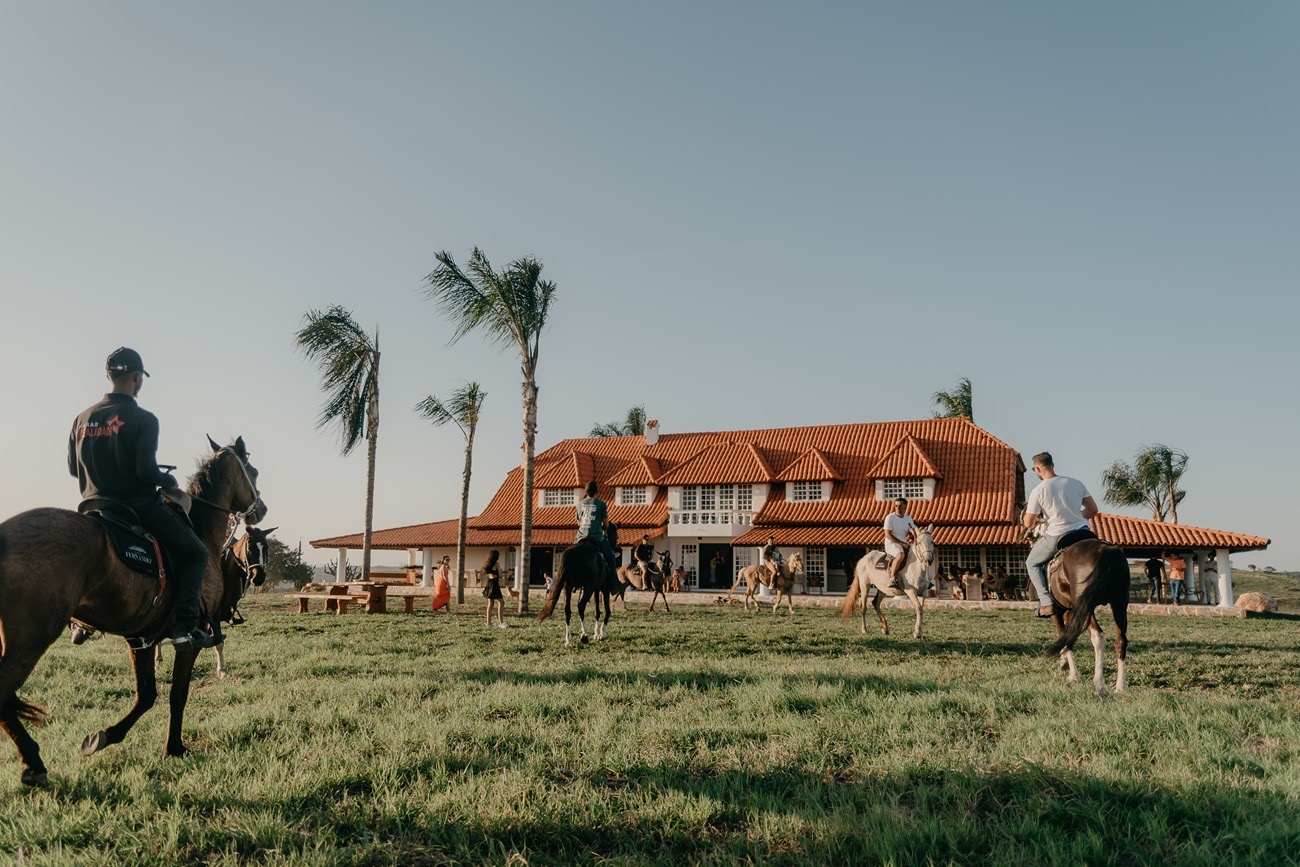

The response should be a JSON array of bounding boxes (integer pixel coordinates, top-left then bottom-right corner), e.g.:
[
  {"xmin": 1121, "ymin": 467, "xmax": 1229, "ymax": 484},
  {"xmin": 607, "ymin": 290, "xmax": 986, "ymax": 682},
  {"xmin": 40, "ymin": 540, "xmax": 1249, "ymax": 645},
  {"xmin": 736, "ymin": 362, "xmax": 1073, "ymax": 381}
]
[{"xmin": 312, "ymin": 419, "xmax": 1269, "ymax": 604}]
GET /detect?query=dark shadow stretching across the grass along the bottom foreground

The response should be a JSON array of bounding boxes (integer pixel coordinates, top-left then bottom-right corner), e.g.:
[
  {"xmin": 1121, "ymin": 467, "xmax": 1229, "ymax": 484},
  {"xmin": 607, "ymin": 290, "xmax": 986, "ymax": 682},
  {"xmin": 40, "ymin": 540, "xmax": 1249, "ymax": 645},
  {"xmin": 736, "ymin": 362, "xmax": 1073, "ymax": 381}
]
[{"xmin": 81, "ymin": 757, "xmax": 1300, "ymax": 867}]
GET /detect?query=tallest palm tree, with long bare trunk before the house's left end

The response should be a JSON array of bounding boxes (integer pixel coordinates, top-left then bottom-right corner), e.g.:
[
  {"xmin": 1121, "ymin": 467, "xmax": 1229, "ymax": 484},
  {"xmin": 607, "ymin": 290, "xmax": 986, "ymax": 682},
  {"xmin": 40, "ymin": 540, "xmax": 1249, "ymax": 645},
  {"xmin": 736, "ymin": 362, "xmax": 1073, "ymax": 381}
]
[{"xmin": 424, "ymin": 247, "xmax": 555, "ymax": 612}]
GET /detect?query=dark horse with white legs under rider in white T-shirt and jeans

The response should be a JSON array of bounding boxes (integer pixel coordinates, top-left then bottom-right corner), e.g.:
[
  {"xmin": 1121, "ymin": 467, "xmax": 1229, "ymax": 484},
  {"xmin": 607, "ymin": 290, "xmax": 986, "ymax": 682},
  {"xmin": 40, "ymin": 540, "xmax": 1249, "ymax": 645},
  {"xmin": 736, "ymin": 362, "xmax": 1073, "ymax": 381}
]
[{"xmin": 1047, "ymin": 538, "xmax": 1128, "ymax": 695}]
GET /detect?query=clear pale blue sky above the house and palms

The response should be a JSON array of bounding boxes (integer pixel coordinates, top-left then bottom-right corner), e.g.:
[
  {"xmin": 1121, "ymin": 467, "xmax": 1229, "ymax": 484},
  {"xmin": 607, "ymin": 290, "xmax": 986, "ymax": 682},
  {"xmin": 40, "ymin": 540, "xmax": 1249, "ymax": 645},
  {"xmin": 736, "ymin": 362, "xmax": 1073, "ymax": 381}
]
[{"xmin": 0, "ymin": 0, "xmax": 1300, "ymax": 569}]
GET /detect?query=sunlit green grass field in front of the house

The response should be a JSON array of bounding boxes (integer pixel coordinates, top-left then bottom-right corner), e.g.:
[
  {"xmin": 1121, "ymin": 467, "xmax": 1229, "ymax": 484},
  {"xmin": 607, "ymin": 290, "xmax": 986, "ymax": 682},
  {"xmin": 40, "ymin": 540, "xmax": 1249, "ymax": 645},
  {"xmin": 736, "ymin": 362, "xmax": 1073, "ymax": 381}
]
[{"xmin": 0, "ymin": 598, "xmax": 1300, "ymax": 867}]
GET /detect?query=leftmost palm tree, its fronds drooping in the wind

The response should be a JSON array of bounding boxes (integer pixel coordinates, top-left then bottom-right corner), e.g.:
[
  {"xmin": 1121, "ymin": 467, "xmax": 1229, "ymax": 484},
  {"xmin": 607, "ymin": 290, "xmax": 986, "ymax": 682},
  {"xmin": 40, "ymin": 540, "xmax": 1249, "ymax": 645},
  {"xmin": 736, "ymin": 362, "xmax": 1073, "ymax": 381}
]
[{"xmin": 294, "ymin": 305, "xmax": 380, "ymax": 580}]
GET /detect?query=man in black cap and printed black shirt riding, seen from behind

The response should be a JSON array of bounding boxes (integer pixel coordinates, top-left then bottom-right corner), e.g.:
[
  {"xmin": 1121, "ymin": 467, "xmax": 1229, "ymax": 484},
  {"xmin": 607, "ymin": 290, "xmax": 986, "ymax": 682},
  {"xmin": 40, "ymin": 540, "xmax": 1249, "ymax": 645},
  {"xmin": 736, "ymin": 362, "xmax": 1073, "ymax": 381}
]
[{"xmin": 68, "ymin": 347, "xmax": 212, "ymax": 651}]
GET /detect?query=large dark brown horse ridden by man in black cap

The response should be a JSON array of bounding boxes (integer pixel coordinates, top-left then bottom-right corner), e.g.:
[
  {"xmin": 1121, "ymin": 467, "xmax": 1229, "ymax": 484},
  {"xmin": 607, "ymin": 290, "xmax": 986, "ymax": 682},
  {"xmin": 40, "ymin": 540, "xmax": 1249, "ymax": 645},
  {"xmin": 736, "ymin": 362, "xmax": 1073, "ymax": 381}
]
[{"xmin": 0, "ymin": 437, "xmax": 267, "ymax": 785}]
